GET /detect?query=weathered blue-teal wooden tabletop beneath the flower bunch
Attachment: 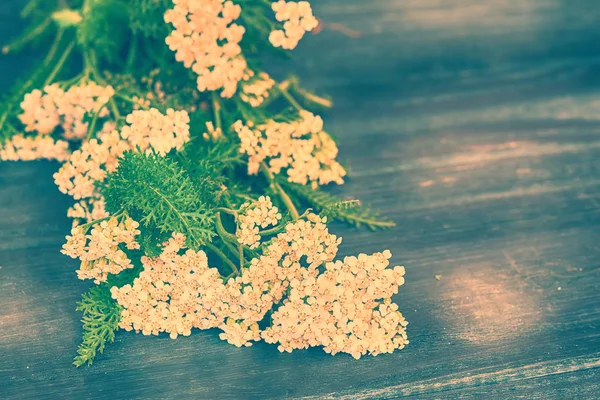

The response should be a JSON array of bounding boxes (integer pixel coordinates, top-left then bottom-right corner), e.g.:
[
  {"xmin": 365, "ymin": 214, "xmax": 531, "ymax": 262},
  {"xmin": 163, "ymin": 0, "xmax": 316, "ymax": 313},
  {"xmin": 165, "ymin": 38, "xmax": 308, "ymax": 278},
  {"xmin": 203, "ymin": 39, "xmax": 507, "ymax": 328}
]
[{"xmin": 0, "ymin": 0, "xmax": 600, "ymax": 399}]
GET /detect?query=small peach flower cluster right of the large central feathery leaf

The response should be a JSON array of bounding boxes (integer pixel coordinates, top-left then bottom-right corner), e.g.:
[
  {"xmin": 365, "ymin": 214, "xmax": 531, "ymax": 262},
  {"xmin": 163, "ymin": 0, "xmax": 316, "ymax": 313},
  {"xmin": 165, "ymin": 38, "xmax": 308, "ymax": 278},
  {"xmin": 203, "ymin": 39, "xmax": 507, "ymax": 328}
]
[{"xmin": 236, "ymin": 196, "xmax": 281, "ymax": 249}]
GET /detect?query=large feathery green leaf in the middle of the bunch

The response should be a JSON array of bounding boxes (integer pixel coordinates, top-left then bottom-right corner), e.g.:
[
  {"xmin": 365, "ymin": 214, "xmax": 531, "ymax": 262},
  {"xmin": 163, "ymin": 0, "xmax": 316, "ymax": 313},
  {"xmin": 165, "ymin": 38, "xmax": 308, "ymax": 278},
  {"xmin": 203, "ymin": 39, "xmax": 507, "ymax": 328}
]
[{"xmin": 101, "ymin": 152, "xmax": 214, "ymax": 249}]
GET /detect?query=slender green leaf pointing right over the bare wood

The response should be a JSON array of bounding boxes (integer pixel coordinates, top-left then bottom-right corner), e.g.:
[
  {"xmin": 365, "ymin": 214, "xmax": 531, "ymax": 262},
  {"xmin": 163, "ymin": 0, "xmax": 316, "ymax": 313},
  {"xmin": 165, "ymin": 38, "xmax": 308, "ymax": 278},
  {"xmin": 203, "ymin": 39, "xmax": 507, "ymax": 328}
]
[{"xmin": 281, "ymin": 181, "xmax": 396, "ymax": 230}]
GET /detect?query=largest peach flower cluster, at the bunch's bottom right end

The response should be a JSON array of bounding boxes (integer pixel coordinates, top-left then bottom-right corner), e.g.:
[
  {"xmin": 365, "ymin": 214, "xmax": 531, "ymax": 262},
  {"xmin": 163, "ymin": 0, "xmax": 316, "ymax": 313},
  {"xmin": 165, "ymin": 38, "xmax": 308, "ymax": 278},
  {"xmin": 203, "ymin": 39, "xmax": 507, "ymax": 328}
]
[{"xmin": 261, "ymin": 251, "xmax": 408, "ymax": 359}]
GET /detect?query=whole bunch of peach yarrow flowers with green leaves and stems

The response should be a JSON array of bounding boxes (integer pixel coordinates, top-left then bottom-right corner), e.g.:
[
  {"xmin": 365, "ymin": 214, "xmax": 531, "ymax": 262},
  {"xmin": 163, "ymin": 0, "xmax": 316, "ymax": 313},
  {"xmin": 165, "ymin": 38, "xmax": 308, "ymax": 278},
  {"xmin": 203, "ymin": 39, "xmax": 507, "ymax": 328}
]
[{"xmin": 0, "ymin": 0, "xmax": 408, "ymax": 366}]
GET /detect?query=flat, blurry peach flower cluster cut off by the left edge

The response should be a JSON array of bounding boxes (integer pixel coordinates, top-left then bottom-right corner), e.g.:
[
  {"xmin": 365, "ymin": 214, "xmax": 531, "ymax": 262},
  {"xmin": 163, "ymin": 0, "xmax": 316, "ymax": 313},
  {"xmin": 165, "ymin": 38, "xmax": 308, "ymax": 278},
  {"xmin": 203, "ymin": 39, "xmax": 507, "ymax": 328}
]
[{"xmin": 0, "ymin": 135, "xmax": 71, "ymax": 161}]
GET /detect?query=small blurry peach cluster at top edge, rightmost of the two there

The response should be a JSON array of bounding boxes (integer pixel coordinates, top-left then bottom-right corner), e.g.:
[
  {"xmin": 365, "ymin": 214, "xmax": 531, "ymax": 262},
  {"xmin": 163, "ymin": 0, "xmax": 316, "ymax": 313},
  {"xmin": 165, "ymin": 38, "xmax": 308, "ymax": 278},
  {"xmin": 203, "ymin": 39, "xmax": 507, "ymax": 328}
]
[{"xmin": 269, "ymin": 0, "xmax": 319, "ymax": 50}]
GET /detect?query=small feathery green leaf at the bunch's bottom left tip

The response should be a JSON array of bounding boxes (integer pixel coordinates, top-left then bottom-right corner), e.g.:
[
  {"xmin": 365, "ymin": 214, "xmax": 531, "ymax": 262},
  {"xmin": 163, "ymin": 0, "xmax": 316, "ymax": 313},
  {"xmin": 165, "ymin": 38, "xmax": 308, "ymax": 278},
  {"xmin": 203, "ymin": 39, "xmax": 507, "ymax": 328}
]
[{"xmin": 73, "ymin": 284, "xmax": 121, "ymax": 367}]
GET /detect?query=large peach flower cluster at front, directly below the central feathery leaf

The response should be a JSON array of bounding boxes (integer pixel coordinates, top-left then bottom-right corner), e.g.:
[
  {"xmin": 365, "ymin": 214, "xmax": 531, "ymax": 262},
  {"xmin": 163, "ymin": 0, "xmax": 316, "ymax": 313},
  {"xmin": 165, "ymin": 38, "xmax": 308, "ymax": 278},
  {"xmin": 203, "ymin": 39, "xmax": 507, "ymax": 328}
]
[{"xmin": 111, "ymin": 233, "xmax": 224, "ymax": 339}]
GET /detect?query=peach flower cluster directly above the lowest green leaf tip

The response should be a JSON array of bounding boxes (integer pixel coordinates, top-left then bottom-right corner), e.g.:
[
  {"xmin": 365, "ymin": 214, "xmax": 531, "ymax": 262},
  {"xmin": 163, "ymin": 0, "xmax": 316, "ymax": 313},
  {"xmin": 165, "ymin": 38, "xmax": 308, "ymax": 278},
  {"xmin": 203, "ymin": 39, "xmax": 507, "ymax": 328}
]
[{"xmin": 62, "ymin": 217, "xmax": 140, "ymax": 283}]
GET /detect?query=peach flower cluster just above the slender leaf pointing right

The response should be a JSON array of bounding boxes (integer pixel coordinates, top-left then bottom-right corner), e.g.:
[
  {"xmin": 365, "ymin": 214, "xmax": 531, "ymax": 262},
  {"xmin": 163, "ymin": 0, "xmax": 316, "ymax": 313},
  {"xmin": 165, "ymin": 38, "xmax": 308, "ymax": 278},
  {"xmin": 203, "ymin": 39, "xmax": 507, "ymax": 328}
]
[{"xmin": 233, "ymin": 111, "xmax": 346, "ymax": 186}]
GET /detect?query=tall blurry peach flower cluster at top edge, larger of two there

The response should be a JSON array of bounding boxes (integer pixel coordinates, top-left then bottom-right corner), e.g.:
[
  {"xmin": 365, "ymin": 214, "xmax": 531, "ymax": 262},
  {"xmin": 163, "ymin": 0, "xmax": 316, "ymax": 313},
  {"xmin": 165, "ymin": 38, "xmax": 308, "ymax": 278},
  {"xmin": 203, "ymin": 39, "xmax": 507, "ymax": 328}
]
[{"xmin": 165, "ymin": 0, "xmax": 249, "ymax": 98}]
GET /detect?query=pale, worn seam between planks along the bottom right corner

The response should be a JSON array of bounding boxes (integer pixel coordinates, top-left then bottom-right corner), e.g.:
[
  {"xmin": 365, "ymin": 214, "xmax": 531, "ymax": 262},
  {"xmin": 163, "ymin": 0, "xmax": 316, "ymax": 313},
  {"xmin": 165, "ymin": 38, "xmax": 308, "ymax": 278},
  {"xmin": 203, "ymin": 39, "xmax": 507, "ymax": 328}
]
[{"xmin": 302, "ymin": 353, "xmax": 600, "ymax": 400}]
